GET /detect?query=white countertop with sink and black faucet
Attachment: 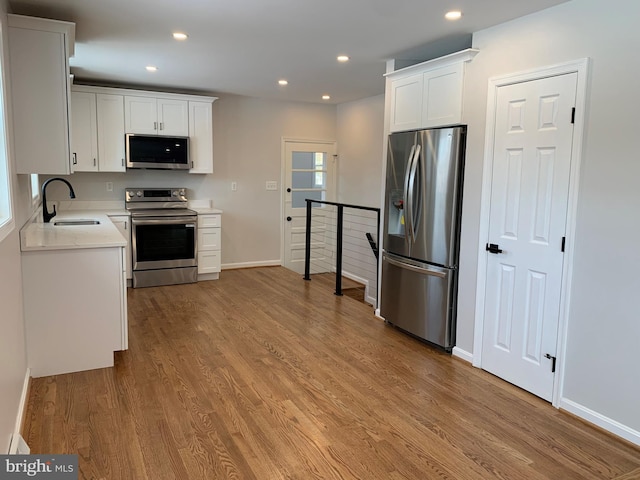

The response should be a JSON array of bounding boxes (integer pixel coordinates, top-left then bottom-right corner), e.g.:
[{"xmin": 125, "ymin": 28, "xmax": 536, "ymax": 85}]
[{"xmin": 20, "ymin": 210, "xmax": 127, "ymax": 252}]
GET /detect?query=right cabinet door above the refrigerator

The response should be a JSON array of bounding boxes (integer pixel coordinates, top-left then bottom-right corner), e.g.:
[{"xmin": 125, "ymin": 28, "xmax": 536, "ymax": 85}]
[{"xmin": 422, "ymin": 62, "xmax": 464, "ymax": 128}]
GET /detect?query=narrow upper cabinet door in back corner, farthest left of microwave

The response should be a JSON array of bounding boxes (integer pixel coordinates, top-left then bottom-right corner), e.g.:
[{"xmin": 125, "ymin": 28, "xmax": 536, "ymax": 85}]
[{"xmin": 71, "ymin": 92, "xmax": 98, "ymax": 172}]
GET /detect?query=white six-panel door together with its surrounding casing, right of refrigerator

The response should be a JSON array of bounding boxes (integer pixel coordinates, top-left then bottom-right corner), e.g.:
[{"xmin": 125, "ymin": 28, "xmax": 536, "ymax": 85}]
[{"xmin": 473, "ymin": 59, "xmax": 588, "ymax": 406}]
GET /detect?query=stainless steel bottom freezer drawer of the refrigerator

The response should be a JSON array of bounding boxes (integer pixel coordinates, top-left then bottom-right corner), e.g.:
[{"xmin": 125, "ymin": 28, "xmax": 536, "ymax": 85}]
[{"xmin": 380, "ymin": 253, "xmax": 457, "ymax": 350}]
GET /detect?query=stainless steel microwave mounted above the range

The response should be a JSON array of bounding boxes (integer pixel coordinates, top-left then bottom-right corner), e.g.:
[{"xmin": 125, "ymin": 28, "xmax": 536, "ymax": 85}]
[{"xmin": 125, "ymin": 133, "xmax": 191, "ymax": 170}]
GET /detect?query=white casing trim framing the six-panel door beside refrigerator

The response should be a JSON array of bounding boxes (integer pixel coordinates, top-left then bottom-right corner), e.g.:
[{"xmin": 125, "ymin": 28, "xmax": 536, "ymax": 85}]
[{"xmin": 472, "ymin": 58, "xmax": 590, "ymax": 407}]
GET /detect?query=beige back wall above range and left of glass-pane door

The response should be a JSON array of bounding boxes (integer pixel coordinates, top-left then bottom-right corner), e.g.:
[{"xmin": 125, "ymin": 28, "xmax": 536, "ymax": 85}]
[{"xmin": 47, "ymin": 95, "xmax": 336, "ymax": 268}]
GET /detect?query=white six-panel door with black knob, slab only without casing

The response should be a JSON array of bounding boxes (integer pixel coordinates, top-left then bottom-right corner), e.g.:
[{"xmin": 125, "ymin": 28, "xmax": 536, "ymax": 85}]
[{"xmin": 482, "ymin": 73, "xmax": 577, "ymax": 400}]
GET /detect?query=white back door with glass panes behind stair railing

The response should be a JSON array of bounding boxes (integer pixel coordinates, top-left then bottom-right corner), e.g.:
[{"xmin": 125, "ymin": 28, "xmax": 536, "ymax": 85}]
[{"xmin": 283, "ymin": 141, "xmax": 336, "ymax": 274}]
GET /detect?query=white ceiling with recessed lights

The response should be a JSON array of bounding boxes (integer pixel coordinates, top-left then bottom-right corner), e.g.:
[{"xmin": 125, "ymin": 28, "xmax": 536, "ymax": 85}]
[{"xmin": 9, "ymin": 0, "xmax": 566, "ymax": 103}]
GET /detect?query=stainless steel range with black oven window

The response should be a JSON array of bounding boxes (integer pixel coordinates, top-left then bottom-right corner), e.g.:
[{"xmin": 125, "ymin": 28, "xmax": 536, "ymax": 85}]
[{"xmin": 125, "ymin": 188, "xmax": 198, "ymax": 288}]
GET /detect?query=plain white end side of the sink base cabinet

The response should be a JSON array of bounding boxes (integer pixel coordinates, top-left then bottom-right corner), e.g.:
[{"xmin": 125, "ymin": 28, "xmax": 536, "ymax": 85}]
[{"xmin": 22, "ymin": 247, "xmax": 127, "ymax": 377}]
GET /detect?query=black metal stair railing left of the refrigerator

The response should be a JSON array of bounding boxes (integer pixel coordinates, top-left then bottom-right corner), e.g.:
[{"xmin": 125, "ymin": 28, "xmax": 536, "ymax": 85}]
[{"xmin": 304, "ymin": 198, "xmax": 380, "ymax": 296}]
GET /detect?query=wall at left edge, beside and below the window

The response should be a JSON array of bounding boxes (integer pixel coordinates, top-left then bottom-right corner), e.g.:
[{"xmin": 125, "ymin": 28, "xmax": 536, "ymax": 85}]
[{"xmin": 0, "ymin": 0, "xmax": 30, "ymax": 453}]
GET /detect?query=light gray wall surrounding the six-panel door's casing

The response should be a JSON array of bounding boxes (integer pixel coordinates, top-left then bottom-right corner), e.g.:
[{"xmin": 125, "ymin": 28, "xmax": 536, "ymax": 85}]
[{"xmin": 458, "ymin": 0, "xmax": 640, "ymax": 441}]
